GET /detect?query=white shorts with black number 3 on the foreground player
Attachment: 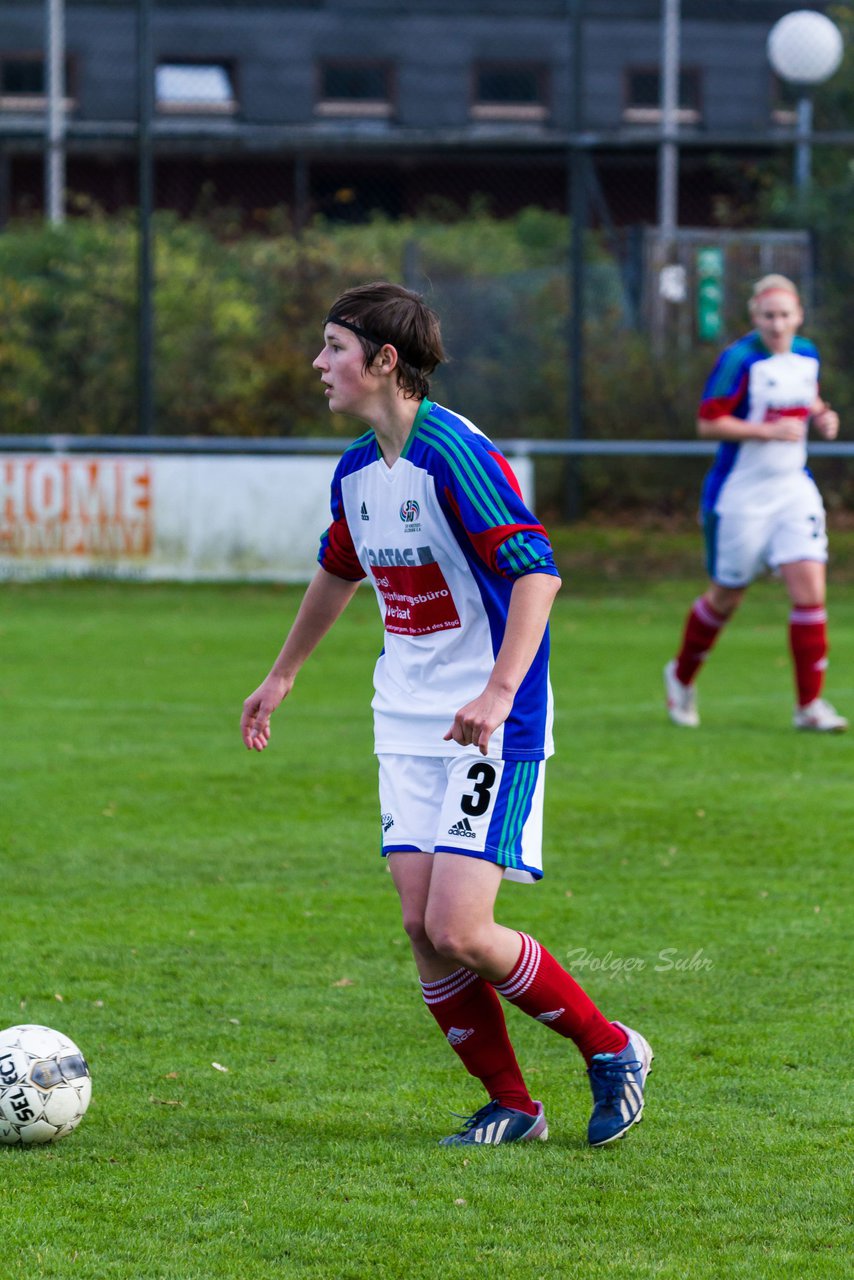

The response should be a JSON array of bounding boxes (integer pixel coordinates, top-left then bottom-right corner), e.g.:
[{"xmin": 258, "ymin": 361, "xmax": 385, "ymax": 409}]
[{"xmin": 378, "ymin": 754, "xmax": 545, "ymax": 883}]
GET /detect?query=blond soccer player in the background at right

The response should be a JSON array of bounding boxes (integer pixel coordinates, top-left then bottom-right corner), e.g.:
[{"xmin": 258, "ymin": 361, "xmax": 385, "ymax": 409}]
[{"xmin": 665, "ymin": 275, "xmax": 848, "ymax": 733}]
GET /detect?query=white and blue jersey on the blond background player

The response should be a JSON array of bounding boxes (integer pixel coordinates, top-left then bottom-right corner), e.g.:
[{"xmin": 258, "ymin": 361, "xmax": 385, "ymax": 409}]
[{"xmin": 699, "ymin": 333, "xmax": 819, "ymax": 513}]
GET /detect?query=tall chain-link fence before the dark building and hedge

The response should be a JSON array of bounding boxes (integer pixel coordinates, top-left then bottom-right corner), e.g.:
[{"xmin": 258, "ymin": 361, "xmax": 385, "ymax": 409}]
[{"xmin": 0, "ymin": 0, "xmax": 854, "ymax": 511}]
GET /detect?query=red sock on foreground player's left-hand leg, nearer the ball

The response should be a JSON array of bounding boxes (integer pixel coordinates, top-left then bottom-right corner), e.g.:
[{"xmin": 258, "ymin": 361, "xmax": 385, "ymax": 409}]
[{"xmin": 421, "ymin": 969, "xmax": 536, "ymax": 1116}]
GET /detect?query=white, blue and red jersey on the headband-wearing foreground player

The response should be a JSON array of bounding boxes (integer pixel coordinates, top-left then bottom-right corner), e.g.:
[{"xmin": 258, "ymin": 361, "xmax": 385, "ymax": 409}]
[{"xmin": 318, "ymin": 399, "xmax": 557, "ymax": 760}]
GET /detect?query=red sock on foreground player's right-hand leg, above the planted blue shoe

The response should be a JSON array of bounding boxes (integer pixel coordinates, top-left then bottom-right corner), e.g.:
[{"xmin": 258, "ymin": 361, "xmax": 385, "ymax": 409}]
[{"xmin": 495, "ymin": 933, "xmax": 627, "ymax": 1064}]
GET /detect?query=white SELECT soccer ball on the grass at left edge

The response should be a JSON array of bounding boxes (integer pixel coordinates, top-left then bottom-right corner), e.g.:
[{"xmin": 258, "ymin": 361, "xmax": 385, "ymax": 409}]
[{"xmin": 0, "ymin": 1023, "xmax": 92, "ymax": 1146}]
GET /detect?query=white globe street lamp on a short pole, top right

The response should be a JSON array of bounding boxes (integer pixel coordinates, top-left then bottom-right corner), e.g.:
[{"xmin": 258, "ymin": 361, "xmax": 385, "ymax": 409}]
[{"xmin": 766, "ymin": 9, "xmax": 844, "ymax": 195}]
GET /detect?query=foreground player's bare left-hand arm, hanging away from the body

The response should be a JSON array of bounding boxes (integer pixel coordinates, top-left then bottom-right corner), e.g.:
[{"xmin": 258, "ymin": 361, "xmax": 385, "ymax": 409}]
[{"xmin": 241, "ymin": 568, "xmax": 359, "ymax": 751}]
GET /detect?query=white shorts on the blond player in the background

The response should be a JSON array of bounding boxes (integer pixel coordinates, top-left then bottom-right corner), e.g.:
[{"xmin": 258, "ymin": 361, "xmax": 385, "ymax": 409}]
[{"xmin": 703, "ymin": 476, "xmax": 827, "ymax": 588}]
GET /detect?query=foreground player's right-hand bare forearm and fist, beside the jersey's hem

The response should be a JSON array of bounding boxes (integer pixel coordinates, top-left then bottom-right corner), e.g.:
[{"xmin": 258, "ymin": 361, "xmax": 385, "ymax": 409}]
[{"xmin": 444, "ymin": 573, "xmax": 561, "ymax": 755}]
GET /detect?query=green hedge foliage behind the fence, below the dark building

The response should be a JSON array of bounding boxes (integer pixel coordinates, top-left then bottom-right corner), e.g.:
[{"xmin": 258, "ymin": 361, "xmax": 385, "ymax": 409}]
[{"xmin": 0, "ymin": 189, "xmax": 854, "ymax": 511}]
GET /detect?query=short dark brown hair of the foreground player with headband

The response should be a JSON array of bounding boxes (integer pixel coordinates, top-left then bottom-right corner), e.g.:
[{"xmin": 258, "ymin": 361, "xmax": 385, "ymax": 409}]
[{"xmin": 324, "ymin": 280, "xmax": 446, "ymax": 399}]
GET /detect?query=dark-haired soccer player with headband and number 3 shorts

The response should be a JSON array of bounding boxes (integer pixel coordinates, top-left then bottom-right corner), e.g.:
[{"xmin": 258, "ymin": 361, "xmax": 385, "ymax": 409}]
[{"xmin": 241, "ymin": 282, "xmax": 652, "ymax": 1146}]
